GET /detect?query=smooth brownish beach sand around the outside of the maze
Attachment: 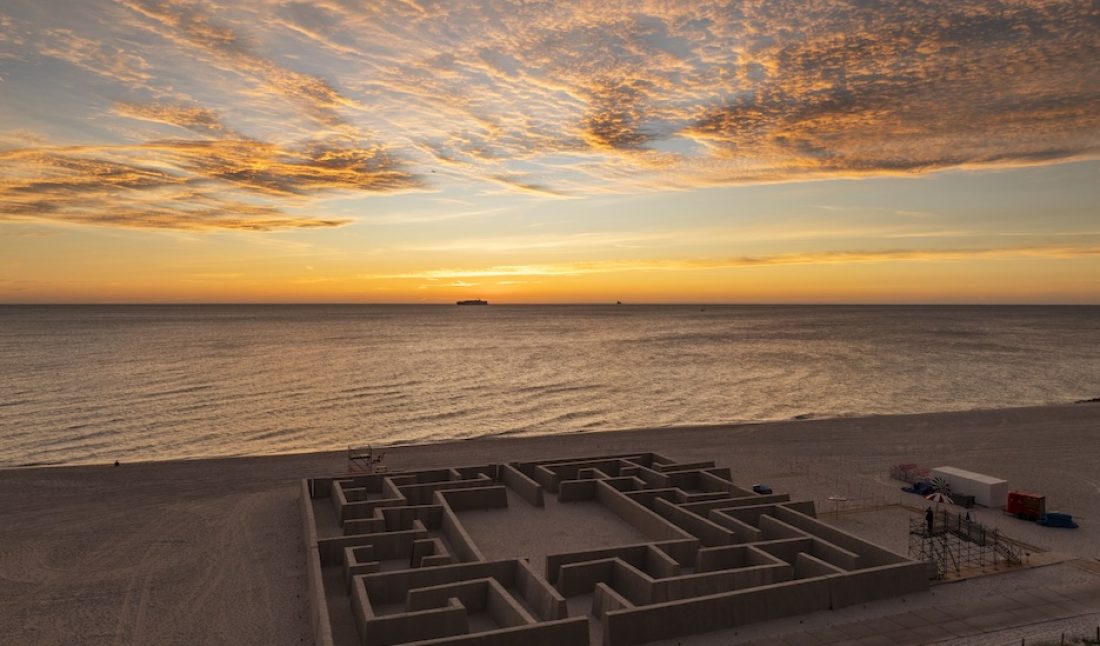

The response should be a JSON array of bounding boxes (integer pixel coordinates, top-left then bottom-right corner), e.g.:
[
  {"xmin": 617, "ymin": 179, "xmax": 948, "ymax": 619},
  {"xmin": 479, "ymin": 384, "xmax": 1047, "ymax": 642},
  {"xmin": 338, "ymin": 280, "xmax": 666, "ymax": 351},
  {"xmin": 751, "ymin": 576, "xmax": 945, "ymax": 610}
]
[{"xmin": 0, "ymin": 404, "xmax": 1100, "ymax": 645}]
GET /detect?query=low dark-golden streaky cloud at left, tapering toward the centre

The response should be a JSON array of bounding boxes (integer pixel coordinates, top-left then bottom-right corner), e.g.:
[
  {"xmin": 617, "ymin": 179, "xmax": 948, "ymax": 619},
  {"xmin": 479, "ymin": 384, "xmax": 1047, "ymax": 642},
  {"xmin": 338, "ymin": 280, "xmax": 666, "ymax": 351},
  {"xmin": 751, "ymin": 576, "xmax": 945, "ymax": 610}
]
[{"xmin": 0, "ymin": 122, "xmax": 417, "ymax": 231}]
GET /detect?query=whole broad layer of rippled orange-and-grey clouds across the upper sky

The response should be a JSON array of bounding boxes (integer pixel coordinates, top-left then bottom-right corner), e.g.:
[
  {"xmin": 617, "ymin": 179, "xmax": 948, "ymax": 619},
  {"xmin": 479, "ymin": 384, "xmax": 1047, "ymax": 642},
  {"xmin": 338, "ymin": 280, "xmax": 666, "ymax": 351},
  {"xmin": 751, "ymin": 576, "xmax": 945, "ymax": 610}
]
[{"xmin": 0, "ymin": 0, "xmax": 1100, "ymax": 230}]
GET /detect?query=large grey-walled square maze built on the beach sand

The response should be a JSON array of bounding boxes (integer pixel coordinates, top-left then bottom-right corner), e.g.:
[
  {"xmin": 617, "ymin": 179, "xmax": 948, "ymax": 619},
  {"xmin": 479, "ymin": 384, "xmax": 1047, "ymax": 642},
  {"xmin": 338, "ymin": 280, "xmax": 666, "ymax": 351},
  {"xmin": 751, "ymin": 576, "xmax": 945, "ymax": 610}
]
[{"xmin": 301, "ymin": 453, "xmax": 927, "ymax": 646}]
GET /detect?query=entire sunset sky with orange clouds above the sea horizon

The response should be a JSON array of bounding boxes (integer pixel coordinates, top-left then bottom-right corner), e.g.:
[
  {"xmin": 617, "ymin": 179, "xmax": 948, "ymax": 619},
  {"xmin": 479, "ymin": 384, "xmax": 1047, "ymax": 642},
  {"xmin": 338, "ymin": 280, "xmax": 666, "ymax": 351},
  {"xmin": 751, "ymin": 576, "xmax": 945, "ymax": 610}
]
[{"xmin": 0, "ymin": 0, "xmax": 1100, "ymax": 304}]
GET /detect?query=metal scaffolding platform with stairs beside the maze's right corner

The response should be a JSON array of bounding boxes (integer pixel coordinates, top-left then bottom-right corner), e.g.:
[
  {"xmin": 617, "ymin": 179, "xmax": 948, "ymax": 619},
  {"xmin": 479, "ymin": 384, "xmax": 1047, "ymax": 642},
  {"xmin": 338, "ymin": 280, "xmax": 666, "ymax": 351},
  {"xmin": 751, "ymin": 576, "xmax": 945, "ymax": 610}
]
[{"xmin": 909, "ymin": 510, "xmax": 1023, "ymax": 579}]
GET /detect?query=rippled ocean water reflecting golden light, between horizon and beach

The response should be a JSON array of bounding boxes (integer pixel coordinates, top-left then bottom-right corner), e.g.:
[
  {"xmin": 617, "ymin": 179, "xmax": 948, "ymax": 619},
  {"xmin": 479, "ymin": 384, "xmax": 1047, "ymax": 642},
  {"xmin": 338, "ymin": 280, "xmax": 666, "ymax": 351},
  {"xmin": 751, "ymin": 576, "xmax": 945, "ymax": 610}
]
[{"xmin": 0, "ymin": 305, "xmax": 1100, "ymax": 467}]
